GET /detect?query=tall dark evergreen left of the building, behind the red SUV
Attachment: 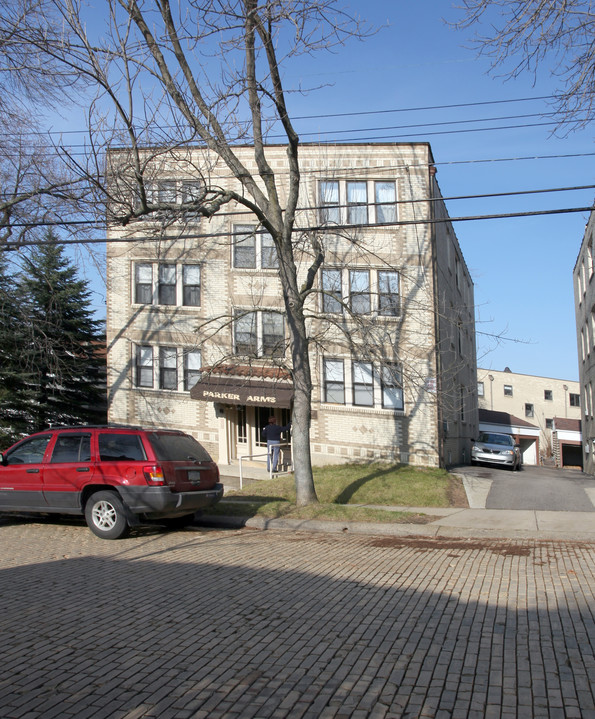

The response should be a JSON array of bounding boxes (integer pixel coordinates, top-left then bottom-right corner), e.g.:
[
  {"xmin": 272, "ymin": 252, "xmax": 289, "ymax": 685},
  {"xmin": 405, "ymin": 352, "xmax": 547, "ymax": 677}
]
[{"xmin": 20, "ymin": 232, "xmax": 106, "ymax": 431}]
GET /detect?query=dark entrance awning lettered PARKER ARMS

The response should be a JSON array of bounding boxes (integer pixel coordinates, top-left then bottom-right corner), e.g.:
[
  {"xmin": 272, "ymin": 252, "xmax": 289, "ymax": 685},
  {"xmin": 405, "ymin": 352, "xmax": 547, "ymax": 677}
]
[{"xmin": 190, "ymin": 368, "xmax": 293, "ymax": 408}]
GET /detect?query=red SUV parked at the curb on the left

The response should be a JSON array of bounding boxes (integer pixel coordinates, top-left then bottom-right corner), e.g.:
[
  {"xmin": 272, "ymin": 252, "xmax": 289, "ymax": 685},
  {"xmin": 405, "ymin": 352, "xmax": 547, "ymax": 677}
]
[{"xmin": 0, "ymin": 426, "xmax": 223, "ymax": 539}]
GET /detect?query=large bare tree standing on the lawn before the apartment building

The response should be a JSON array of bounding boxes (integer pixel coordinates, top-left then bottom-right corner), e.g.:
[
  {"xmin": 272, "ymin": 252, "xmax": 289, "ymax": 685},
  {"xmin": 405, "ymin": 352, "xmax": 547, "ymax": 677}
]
[{"xmin": 18, "ymin": 0, "xmax": 365, "ymax": 505}]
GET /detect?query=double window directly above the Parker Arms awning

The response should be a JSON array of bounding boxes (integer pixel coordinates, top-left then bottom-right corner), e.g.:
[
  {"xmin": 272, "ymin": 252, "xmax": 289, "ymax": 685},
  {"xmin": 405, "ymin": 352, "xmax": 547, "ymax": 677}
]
[{"xmin": 233, "ymin": 309, "xmax": 285, "ymax": 357}]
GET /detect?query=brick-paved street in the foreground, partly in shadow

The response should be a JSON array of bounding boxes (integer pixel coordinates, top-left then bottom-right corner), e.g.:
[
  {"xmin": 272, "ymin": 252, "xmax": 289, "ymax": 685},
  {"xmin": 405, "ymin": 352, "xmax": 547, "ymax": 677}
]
[{"xmin": 0, "ymin": 521, "xmax": 595, "ymax": 719}]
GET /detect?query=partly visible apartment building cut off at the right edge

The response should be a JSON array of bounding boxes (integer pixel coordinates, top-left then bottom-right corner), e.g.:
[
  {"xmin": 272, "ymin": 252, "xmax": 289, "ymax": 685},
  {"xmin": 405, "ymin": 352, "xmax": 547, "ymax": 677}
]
[{"xmin": 573, "ymin": 212, "xmax": 595, "ymax": 475}]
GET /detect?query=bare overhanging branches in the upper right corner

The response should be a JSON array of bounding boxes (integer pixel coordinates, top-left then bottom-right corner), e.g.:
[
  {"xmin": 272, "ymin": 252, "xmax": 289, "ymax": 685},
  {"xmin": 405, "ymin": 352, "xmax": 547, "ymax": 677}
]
[{"xmin": 455, "ymin": 0, "xmax": 595, "ymax": 127}]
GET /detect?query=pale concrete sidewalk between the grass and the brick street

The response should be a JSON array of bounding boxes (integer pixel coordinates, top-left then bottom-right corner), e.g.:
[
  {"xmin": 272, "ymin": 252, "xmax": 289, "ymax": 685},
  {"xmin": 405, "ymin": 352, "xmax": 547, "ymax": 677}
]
[{"xmin": 208, "ymin": 476, "xmax": 595, "ymax": 541}]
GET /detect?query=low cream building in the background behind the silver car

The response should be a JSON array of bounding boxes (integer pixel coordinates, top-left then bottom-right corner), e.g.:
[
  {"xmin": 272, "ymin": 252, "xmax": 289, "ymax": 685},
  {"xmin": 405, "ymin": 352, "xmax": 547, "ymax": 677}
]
[{"xmin": 477, "ymin": 367, "xmax": 581, "ymax": 466}]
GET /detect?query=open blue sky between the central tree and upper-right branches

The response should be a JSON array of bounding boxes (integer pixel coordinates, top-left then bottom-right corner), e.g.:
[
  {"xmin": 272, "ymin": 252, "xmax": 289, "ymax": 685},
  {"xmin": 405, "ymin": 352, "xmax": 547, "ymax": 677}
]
[{"xmin": 59, "ymin": 0, "xmax": 595, "ymax": 380}]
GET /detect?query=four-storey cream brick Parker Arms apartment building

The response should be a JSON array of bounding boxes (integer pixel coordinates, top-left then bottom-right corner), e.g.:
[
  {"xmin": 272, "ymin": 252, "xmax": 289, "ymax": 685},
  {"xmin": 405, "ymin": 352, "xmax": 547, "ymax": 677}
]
[{"xmin": 107, "ymin": 143, "xmax": 477, "ymax": 471}]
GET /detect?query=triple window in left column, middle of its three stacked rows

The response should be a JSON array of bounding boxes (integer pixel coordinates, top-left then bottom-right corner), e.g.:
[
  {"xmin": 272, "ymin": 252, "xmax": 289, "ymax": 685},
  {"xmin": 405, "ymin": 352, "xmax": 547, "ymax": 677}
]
[{"xmin": 133, "ymin": 262, "xmax": 201, "ymax": 307}]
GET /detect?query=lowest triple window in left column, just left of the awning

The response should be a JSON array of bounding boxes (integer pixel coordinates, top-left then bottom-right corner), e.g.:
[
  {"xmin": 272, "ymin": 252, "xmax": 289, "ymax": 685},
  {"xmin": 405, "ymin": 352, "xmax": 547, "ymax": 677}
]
[{"xmin": 134, "ymin": 345, "xmax": 201, "ymax": 392}]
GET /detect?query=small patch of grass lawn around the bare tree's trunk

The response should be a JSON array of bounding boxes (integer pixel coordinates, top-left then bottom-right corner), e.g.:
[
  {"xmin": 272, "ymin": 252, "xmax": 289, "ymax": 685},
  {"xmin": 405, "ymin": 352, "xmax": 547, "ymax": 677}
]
[{"xmin": 208, "ymin": 463, "xmax": 468, "ymax": 523}]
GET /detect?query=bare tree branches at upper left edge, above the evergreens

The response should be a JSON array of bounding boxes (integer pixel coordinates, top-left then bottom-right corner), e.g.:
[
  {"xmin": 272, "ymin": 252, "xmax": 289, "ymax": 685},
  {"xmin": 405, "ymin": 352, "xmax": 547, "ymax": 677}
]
[{"xmin": 0, "ymin": 0, "xmax": 92, "ymax": 246}]
